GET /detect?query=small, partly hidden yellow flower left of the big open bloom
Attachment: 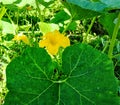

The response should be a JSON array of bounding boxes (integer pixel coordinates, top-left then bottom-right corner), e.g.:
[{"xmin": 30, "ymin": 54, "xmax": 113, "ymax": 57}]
[{"xmin": 13, "ymin": 33, "xmax": 30, "ymax": 44}]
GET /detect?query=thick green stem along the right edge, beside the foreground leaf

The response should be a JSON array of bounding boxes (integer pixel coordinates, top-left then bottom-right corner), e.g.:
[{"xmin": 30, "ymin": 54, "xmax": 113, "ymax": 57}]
[{"xmin": 108, "ymin": 13, "xmax": 120, "ymax": 58}]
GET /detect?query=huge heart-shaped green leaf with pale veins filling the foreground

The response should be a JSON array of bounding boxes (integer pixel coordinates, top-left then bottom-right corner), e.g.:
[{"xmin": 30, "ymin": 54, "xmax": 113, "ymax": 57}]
[{"xmin": 4, "ymin": 44, "xmax": 119, "ymax": 105}]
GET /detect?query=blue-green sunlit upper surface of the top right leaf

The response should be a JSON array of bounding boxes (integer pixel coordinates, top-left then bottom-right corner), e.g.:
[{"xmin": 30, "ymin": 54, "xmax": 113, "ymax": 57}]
[{"xmin": 66, "ymin": 0, "xmax": 120, "ymax": 12}]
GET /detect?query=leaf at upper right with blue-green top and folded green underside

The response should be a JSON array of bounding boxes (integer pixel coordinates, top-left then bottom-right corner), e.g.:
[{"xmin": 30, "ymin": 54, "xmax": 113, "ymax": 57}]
[{"xmin": 63, "ymin": 0, "xmax": 120, "ymax": 19}]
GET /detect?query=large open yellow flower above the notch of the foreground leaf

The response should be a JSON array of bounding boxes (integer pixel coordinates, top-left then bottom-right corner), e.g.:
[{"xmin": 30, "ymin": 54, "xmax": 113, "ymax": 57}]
[{"xmin": 39, "ymin": 30, "xmax": 70, "ymax": 55}]
